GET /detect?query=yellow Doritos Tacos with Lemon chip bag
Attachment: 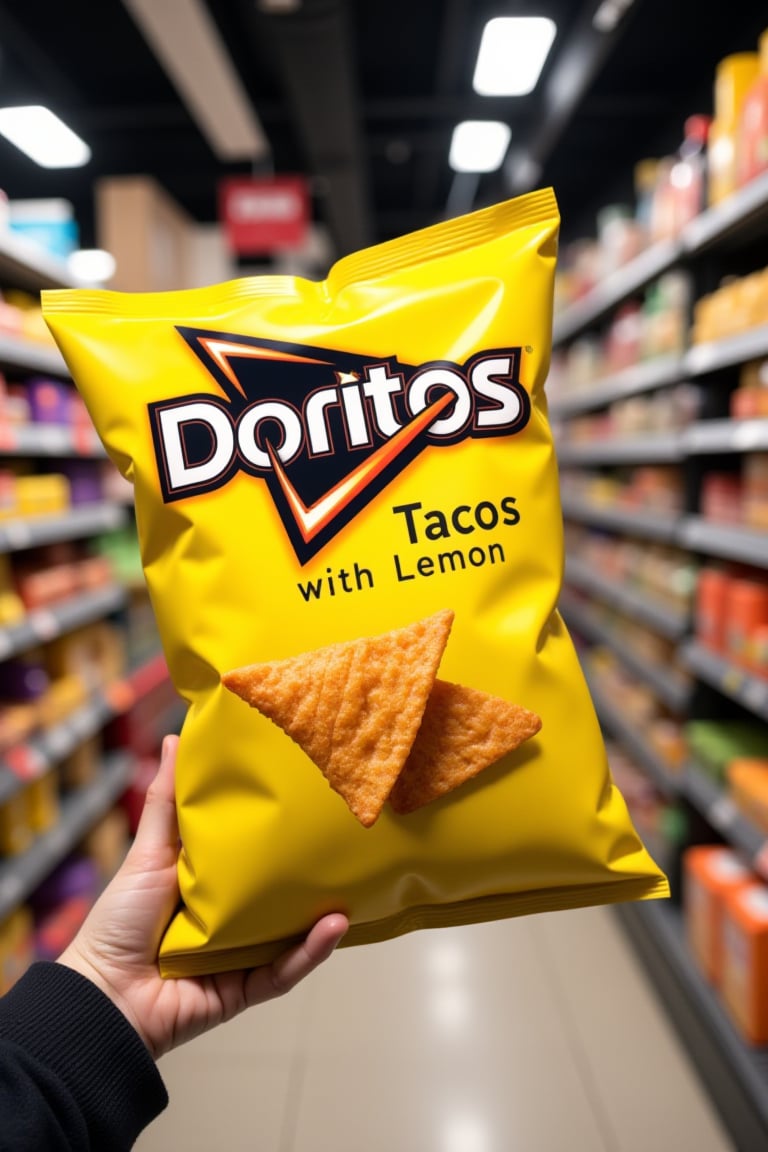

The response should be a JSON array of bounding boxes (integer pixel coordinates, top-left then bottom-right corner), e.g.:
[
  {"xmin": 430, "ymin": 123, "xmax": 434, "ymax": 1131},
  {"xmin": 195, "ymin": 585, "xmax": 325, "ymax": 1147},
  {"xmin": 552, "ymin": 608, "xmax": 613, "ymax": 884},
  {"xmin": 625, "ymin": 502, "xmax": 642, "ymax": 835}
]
[{"xmin": 43, "ymin": 189, "xmax": 668, "ymax": 976}]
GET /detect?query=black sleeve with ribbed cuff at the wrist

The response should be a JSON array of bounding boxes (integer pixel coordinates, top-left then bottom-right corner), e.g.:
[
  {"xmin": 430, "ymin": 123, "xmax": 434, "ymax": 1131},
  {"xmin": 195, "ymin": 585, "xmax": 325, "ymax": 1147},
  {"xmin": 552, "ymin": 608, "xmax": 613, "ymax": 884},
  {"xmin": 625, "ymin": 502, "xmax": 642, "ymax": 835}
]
[{"xmin": 0, "ymin": 963, "xmax": 168, "ymax": 1152}]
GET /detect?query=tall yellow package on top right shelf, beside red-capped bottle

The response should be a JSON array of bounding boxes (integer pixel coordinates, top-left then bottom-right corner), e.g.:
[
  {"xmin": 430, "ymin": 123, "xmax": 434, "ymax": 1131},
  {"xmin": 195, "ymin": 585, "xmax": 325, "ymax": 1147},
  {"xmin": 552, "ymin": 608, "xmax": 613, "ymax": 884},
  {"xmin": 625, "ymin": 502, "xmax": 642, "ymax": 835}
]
[{"xmin": 707, "ymin": 52, "xmax": 760, "ymax": 205}]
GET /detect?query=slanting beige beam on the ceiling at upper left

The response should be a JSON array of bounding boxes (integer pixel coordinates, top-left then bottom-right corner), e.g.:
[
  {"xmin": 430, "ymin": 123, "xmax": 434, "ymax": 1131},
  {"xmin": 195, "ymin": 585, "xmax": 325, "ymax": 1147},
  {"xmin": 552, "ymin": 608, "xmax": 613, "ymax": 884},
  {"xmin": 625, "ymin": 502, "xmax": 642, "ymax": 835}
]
[{"xmin": 123, "ymin": 0, "xmax": 269, "ymax": 160}]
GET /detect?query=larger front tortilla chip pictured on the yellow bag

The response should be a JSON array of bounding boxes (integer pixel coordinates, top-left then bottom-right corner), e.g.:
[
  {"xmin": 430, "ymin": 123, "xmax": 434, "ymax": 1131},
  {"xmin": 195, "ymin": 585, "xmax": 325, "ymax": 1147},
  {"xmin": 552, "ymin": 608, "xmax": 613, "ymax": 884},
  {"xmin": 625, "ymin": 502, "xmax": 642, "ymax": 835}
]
[{"xmin": 221, "ymin": 609, "xmax": 454, "ymax": 828}]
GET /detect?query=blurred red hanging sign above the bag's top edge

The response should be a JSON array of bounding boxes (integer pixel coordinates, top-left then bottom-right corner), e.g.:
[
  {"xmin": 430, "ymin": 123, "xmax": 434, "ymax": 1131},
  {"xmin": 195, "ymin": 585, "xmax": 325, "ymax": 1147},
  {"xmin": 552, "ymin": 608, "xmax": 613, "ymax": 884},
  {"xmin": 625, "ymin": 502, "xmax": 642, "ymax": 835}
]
[{"xmin": 219, "ymin": 176, "xmax": 310, "ymax": 256}]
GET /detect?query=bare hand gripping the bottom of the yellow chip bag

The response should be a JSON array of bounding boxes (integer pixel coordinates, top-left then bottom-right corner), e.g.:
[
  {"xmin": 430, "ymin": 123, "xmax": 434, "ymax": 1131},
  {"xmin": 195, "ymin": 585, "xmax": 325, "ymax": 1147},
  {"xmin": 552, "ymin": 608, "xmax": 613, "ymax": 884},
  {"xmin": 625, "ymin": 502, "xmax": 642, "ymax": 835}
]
[{"xmin": 59, "ymin": 736, "xmax": 349, "ymax": 1060}]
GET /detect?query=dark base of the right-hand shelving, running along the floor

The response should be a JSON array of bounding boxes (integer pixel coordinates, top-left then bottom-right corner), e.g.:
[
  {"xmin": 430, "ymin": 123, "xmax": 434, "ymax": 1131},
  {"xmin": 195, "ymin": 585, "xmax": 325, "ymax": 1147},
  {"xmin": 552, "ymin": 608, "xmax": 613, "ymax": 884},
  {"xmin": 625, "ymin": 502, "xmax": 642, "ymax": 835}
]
[{"xmin": 616, "ymin": 901, "xmax": 768, "ymax": 1152}]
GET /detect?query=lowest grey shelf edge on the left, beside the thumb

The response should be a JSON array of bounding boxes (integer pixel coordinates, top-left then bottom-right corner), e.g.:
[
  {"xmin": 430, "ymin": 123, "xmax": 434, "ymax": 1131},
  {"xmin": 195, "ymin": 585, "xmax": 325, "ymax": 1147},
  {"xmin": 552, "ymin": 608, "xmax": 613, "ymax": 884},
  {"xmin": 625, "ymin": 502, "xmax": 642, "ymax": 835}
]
[{"xmin": 0, "ymin": 752, "xmax": 135, "ymax": 922}]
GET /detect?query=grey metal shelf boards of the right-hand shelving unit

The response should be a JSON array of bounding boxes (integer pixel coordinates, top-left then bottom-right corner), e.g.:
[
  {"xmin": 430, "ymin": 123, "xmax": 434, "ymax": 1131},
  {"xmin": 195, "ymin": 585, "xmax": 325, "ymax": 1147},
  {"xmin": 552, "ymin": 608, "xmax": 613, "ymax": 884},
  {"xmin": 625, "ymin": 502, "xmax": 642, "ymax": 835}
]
[{"xmin": 552, "ymin": 157, "xmax": 768, "ymax": 1152}]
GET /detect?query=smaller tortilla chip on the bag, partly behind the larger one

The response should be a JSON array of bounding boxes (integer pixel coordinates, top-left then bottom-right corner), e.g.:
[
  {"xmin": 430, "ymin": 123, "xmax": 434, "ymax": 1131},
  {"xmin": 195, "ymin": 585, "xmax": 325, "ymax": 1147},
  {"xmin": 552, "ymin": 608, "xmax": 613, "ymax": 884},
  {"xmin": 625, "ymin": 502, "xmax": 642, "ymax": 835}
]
[{"xmin": 389, "ymin": 680, "xmax": 541, "ymax": 816}]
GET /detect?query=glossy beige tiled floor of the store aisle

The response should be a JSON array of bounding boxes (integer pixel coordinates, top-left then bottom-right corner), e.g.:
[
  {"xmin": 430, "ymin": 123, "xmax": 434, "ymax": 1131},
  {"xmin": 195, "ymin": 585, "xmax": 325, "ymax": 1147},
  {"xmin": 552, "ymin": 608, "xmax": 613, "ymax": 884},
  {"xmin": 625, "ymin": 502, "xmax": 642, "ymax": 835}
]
[{"xmin": 136, "ymin": 909, "xmax": 732, "ymax": 1152}]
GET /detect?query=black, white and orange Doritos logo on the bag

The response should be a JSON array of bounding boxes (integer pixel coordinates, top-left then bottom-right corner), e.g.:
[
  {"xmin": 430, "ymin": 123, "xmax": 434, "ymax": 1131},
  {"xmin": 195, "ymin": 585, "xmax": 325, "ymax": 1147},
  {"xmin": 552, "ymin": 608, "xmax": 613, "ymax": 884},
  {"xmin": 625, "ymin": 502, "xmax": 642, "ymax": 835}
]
[{"xmin": 149, "ymin": 327, "xmax": 531, "ymax": 564}]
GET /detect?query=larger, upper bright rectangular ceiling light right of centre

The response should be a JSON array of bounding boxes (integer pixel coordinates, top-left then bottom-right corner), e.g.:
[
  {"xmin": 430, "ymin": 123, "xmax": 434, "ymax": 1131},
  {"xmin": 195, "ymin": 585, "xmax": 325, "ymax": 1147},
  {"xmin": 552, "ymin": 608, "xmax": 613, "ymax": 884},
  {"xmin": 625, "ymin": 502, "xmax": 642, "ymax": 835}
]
[{"xmin": 472, "ymin": 16, "xmax": 557, "ymax": 96}]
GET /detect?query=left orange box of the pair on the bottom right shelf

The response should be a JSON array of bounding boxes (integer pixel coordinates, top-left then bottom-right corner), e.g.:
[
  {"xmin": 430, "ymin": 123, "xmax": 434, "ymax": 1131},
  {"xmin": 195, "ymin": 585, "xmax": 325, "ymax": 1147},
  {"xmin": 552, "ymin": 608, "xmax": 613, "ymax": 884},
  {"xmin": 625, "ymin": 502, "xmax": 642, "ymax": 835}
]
[{"xmin": 683, "ymin": 844, "xmax": 754, "ymax": 986}]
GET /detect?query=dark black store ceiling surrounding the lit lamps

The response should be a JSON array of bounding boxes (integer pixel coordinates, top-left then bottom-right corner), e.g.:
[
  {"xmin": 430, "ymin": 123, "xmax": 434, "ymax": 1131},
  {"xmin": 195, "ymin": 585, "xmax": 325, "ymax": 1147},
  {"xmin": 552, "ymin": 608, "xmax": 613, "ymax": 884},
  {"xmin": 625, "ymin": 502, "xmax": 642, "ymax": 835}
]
[{"xmin": 0, "ymin": 0, "xmax": 768, "ymax": 270}]
